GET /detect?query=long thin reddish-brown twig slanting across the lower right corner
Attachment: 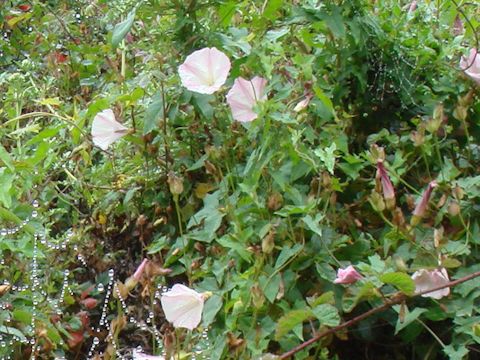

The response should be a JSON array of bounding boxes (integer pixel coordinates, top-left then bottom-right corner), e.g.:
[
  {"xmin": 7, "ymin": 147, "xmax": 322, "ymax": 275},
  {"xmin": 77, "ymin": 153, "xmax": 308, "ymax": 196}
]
[{"xmin": 278, "ymin": 271, "xmax": 480, "ymax": 360}]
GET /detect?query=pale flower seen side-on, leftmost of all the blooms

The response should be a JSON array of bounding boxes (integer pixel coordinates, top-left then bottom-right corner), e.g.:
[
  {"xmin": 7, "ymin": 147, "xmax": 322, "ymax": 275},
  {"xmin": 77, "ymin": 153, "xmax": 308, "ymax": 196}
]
[{"xmin": 92, "ymin": 109, "xmax": 130, "ymax": 150}]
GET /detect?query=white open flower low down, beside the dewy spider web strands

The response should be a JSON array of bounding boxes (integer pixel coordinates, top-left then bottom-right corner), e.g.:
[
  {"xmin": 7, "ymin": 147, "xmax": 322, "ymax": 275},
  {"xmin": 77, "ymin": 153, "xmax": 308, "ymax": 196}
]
[{"xmin": 160, "ymin": 284, "xmax": 206, "ymax": 330}]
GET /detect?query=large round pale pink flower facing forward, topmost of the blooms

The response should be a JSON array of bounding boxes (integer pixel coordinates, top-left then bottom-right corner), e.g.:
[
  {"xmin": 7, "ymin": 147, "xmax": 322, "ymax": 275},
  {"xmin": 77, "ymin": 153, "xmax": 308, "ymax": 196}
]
[{"xmin": 178, "ymin": 47, "xmax": 231, "ymax": 94}]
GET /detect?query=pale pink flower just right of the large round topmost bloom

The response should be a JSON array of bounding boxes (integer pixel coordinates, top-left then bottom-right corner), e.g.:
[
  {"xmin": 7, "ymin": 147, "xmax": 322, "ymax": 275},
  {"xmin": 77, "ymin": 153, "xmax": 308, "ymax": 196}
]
[{"xmin": 227, "ymin": 76, "xmax": 267, "ymax": 122}]
